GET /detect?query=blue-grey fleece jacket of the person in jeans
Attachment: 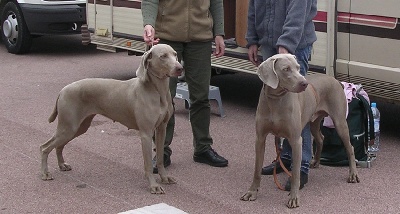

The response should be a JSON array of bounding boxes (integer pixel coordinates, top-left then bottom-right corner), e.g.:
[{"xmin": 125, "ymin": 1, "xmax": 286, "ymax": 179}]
[{"xmin": 246, "ymin": 0, "xmax": 317, "ymax": 54}]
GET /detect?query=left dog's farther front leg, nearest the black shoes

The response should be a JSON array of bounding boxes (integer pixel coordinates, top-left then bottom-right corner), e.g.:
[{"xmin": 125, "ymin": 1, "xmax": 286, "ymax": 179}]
[{"xmin": 155, "ymin": 123, "xmax": 176, "ymax": 184}]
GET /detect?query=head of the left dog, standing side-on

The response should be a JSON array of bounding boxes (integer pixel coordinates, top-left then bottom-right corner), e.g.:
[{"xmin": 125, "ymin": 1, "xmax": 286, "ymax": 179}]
[{"xmin": 136, "ymin": 44, "xmax": 183, "ymax": 80}]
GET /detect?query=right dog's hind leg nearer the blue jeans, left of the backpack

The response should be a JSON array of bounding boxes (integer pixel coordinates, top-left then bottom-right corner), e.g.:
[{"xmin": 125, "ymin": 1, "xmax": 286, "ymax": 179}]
[{"xmin": 310, "ymin": 116, "xmax": 324, "ymax": 168}]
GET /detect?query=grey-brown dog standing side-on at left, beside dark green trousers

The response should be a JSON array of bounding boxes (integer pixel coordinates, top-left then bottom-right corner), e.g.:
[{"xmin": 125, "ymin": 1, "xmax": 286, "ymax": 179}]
[{"xmin": 40, "ymin": 44, "xmax": 183, "ymax": 194}]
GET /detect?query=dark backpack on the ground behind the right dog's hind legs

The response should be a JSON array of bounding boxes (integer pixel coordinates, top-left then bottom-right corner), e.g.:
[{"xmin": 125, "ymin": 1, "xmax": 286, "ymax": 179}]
[{"xmin": 314, "ymin": 93, "xmax": 375, "ymax": 166}]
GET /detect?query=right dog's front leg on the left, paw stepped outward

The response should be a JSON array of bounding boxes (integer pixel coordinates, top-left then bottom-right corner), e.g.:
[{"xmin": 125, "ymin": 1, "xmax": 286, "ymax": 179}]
[{"xmin": 240, "ymin": 133, "xmax": 267, "ymax": 201}]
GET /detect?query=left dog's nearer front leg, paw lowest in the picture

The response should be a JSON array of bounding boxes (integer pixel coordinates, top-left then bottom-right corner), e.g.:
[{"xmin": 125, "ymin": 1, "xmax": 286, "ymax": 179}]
[{"xmin": 140, "ymin": 131, "xmax": 165, "ymax": 194}]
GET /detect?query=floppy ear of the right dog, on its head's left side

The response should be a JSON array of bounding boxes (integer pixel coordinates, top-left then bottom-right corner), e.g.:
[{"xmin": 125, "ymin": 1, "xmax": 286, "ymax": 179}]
[{"xmin": 257, "ymin": 56, "xmax": 279, "ymax": 89}]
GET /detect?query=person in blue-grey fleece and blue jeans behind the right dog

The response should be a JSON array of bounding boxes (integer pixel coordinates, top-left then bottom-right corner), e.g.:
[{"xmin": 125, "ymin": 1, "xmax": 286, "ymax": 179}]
[{"xmin": 246, "ymin": 0, "xmax": 317, "ymax": 191}]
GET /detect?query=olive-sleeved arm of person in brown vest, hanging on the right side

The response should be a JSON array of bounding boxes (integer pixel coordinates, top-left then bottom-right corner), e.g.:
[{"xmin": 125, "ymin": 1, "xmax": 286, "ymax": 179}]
[{"xmin": 210, "ymin": 0, "xmax": 225, "ymax": 57}]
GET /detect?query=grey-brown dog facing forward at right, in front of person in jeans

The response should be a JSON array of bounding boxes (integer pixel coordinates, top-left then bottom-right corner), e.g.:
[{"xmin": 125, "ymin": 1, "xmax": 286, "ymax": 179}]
[{"xmin": 241, "ymin": 54, "xmax": 360, "ymax": 208}]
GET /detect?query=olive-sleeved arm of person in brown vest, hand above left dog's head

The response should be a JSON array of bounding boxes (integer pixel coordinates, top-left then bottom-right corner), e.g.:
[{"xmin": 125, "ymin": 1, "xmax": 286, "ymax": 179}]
[{"xmin": 141, "ymin": 0, "xmax": 159, "ymax": 45}]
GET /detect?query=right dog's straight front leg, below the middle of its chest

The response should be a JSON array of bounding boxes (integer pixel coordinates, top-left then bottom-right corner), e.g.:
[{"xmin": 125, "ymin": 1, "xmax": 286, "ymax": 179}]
[{"xmin": 287, "ymin": 135, "xmax": 302, "ymax": 208}]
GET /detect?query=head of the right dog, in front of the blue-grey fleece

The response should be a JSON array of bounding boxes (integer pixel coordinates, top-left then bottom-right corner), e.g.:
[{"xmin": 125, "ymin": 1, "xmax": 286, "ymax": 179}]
[{"xmin": 257, "ymin": 54, "xmax": 308, "ymax": 93}]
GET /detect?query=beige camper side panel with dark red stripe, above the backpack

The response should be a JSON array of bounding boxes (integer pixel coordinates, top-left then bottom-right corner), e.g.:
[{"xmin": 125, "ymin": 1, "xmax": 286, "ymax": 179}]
[{"xmin": 348, "ymin": 0, "xmax": 400, "ymax": 100}]
